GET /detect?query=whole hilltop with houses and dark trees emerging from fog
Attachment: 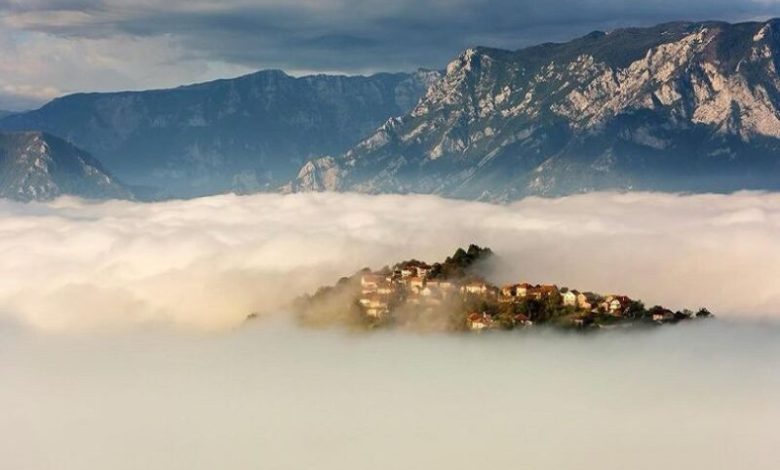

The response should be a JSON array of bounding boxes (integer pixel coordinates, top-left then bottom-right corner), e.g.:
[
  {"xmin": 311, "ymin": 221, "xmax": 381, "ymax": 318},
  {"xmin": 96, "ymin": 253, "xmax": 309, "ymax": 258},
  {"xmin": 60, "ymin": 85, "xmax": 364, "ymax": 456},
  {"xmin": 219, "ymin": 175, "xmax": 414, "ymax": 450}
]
[{"xmin": 296, "ymin": 245, "xmax": 711, "ymax": 331}]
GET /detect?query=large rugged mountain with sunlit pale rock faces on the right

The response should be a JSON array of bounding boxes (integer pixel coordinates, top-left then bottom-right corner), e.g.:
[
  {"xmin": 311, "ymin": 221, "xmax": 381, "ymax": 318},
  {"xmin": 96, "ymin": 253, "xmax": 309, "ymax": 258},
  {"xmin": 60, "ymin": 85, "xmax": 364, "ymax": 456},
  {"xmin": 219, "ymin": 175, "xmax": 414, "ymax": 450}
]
[{"xmin": 289, "ymin": 20, "xmax": 780, "ymax": 201}]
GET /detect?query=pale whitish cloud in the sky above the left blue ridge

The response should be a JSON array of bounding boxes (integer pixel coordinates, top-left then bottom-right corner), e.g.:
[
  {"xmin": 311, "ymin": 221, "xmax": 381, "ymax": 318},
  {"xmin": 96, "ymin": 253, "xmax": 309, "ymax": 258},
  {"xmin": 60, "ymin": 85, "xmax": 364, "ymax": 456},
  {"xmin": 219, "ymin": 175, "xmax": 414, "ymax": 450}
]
[{"xmin": 0, "ymin": 30, "xmax": 251, "ymax": 110}]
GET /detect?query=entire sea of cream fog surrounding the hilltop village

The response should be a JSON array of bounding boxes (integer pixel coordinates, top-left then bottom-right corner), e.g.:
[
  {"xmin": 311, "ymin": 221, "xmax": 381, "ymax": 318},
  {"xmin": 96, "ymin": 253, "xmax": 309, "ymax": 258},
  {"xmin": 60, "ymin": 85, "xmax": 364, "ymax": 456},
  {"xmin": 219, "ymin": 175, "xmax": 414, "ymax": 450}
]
[{"xmin": 0, "ymin": 192, "xmax": 780, "ymax": 470}]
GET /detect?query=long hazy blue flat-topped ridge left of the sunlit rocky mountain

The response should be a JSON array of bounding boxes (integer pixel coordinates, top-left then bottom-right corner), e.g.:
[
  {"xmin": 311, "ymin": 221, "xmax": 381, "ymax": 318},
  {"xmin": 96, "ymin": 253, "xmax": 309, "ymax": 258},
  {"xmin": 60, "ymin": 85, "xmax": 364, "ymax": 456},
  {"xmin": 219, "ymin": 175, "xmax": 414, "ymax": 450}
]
[{"xmin": 0, "ymin": 70, "xmax": 439, "ymax": 197}]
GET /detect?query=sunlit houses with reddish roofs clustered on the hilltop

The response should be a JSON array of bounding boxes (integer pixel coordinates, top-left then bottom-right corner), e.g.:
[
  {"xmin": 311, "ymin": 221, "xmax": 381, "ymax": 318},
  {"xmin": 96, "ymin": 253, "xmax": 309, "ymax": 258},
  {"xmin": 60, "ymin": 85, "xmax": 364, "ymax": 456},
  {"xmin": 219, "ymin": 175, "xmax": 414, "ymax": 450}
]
[{"xmin": 359, "ymin": 262, "xmax": 674, "ymax": 330}]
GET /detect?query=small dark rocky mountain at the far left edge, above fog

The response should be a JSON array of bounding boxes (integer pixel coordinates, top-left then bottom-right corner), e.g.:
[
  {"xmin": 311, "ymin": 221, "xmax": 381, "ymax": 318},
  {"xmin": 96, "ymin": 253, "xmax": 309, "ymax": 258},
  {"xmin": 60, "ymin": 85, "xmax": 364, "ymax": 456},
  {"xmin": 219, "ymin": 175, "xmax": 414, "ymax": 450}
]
[{"xmin": 0, "ymin": 132, "xmax": 132, "ymax": 201}]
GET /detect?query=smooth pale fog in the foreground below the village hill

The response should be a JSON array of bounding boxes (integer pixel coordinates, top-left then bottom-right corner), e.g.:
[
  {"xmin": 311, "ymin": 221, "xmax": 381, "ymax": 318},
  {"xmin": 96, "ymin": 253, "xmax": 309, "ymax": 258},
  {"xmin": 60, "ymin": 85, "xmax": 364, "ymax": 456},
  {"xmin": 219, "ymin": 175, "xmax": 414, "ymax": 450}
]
[{"xmin": 0, "ymin": 320, "xmax": 780, "ymax": 470}]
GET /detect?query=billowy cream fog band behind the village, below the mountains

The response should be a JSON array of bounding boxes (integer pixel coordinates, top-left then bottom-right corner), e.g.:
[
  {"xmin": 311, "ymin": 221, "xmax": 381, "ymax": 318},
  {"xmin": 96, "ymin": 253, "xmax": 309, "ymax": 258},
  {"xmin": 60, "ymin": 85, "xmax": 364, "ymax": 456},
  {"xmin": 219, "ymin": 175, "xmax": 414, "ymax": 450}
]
[{"xmin": 0, "ymin": 193, "xmax": 780, "ymax": 331}]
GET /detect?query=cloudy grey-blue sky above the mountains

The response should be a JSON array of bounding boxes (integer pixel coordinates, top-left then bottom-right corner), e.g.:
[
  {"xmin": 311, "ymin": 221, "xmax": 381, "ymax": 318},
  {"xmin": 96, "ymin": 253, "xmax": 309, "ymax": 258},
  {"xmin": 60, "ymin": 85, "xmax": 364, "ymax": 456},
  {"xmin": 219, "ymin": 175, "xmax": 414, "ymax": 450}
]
[{"xmin": 0, "ymin": 0, "xmax": 780, "ymax": 110}]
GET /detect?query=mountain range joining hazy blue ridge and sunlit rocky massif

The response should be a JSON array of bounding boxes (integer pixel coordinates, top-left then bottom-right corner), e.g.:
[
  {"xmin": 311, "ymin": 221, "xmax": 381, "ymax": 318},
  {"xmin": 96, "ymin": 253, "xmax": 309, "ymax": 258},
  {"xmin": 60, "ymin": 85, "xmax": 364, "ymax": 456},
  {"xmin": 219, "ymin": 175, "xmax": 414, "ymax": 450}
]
[{"xmin": 0, "ymin": 20, "xmax": 780, "ymax": 201}]
